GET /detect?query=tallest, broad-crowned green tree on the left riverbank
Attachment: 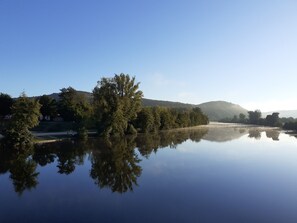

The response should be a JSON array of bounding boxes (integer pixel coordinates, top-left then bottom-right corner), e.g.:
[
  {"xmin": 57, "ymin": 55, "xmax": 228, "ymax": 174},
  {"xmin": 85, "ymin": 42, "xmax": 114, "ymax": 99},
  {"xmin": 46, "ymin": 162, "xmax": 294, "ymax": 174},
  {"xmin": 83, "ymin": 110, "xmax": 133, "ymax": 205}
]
[{"xmin": 93, "ymin": 73, "xmax": 143, "ymax": 136}]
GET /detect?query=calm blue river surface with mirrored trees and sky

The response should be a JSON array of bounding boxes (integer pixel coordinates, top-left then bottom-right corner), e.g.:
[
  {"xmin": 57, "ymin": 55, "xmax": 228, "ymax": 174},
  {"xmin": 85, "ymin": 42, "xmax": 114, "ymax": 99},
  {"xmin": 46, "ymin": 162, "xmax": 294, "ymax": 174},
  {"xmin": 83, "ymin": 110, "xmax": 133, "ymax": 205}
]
[{"xmin": 0, "ymin": 125, "xmax": 297, "ymax": 223}]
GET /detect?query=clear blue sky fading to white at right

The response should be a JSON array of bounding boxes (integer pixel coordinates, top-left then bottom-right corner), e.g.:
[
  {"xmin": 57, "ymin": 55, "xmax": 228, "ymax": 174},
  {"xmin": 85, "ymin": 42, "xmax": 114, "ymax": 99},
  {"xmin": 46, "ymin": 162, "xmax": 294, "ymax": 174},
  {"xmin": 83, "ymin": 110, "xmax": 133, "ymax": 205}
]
[{"xmin": 0, "ymin": 0, "xmax": 297, "ymax": 111}]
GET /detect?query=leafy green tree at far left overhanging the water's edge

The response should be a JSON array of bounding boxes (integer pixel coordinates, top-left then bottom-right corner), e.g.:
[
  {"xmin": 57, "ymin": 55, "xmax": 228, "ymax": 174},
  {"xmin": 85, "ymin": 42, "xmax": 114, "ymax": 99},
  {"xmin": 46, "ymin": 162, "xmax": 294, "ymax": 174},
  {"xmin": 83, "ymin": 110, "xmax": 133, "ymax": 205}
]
[{"xmin": 5, "ymin": 93, "xmax": 40, "ymax": 150}]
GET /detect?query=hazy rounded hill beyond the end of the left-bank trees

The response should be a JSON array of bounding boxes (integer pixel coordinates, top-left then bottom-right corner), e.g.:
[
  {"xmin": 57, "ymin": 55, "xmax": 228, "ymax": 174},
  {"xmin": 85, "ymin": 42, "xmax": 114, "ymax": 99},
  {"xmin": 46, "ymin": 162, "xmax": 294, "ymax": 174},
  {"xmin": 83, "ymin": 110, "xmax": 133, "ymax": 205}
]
[{"xmin": 197, "ymin": 101, "xmax": 248, "ymax": 121}]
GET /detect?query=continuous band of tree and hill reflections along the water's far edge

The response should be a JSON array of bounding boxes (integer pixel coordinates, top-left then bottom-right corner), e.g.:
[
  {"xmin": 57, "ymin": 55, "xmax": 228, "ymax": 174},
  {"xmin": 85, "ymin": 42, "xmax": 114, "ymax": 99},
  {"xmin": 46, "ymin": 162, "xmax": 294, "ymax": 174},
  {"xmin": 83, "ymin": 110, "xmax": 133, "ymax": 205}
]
[{"xmin": 0, "ymin": 127, "xmax": 279, "ymax": 195}]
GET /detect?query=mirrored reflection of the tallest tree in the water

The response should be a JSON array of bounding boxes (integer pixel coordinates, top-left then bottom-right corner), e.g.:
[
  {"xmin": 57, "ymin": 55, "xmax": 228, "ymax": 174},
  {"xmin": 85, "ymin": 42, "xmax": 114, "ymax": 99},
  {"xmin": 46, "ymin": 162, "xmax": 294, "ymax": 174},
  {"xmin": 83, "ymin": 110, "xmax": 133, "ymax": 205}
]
[{"xmin": 90, "ymin": 137, "xmax": 142, "ymax": 193}]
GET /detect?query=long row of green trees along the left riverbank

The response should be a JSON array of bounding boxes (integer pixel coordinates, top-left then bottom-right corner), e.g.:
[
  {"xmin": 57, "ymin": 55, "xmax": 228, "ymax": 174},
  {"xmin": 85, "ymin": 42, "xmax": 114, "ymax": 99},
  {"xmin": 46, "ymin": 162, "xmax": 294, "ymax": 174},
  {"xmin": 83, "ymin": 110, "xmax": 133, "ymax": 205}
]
[{"xmin": 0, "ymin": 73, "xmax": 208, "ymax": 150}]
